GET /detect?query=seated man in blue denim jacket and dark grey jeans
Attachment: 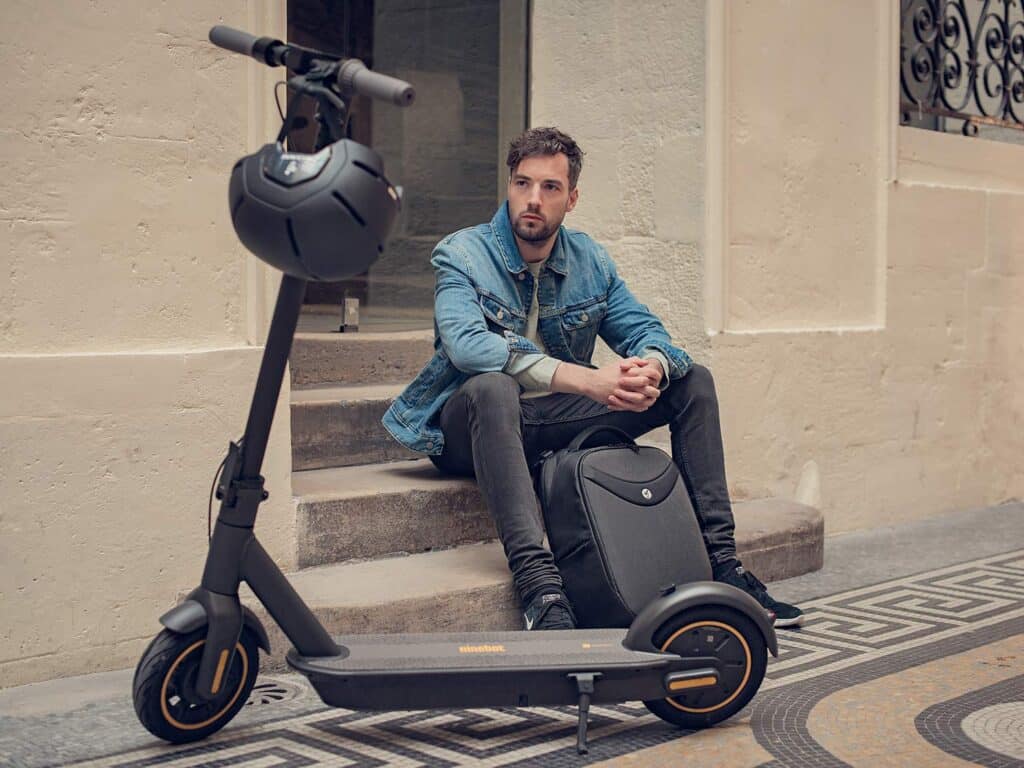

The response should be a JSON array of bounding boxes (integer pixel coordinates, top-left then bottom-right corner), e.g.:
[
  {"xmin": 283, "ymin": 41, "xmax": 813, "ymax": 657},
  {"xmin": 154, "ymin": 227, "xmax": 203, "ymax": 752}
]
[{"xmin": 383, "ymin": 128, "xmax": 803, "ymax": 629}]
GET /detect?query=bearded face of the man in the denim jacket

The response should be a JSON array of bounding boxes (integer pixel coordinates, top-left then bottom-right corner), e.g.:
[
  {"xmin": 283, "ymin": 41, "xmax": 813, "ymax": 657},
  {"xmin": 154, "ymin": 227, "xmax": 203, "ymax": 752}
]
[{"xmin": 509, "ymin": 154, "xmax": 580, "ymax": 243}]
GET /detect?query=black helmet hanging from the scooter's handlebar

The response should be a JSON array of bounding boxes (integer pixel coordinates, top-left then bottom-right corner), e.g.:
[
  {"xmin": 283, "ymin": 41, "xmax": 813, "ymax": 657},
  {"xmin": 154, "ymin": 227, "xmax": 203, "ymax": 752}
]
[{"xmin": 228, "ymin": 139, "xmax": 399, "ymax": 281}]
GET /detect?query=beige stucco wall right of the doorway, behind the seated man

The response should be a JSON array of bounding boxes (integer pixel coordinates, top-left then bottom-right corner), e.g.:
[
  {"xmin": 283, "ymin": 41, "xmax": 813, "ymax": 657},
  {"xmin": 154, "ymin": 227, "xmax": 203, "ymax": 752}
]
[{"xmin": 530, "ymin": 0, "xmax": 1024, "ymax": 535}]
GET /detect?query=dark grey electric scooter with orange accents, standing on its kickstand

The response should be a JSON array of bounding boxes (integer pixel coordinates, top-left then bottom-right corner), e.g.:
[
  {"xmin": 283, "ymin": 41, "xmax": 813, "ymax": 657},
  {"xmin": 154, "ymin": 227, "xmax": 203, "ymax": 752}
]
[{"xmin": 132, "ymin": 27, "xmax": 777, "ymax": 754}]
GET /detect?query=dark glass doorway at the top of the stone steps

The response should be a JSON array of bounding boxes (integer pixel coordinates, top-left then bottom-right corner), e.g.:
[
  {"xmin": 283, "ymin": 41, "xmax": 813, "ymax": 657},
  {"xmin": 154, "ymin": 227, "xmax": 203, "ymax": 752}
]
[{"xmin": 288, "ymin": 0, "xmax": 527, "ymax": 330}]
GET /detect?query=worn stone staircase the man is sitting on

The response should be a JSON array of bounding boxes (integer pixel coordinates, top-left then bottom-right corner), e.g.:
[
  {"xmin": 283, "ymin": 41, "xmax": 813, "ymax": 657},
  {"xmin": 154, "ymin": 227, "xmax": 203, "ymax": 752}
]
[{"xmin": 249, "ymin": 323, "xmax": 823, "ymax": 668}]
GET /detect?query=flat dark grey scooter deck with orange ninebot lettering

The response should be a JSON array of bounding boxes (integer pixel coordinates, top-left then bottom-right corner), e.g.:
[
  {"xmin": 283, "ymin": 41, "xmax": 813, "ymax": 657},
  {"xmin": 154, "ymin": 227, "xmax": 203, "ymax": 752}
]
[{"xmin": 288, "ymin": 630, "xmax": 717, "ymax": 710}]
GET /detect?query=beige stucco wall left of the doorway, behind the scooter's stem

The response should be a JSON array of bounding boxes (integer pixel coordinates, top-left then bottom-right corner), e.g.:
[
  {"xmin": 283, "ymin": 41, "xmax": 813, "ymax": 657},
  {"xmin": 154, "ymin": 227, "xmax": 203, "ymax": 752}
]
[{"xmin": 0, "ymin": 0, "xmax": 294, "ymax": 686}]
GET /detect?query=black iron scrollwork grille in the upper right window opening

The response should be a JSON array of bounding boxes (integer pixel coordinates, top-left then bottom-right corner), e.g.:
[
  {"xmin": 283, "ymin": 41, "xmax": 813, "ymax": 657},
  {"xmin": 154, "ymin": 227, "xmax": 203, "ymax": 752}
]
[{"xmin": 900, "ymin": 0, "xmax": 1024, "ymax": 136}]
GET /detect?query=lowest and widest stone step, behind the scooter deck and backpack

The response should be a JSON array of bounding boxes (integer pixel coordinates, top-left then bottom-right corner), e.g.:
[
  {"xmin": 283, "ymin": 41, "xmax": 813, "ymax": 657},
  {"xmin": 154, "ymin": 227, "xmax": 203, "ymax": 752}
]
[{"xmin": 244, "ymin": 499, "xmax": 824, "ymax": 669}]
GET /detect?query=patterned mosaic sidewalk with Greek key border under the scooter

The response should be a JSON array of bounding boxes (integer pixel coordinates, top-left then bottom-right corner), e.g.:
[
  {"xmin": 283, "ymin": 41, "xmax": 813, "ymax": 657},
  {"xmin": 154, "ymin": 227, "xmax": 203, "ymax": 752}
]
[{"xmin": 0, "ymin": 550, "xmax": 1024, "ymax": 768}]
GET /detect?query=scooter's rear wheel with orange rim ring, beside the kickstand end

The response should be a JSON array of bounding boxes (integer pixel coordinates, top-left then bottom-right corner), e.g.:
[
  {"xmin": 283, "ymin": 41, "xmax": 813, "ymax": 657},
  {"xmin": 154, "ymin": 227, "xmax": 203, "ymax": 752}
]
[{"xmin": 644, "ymin": 605, "xmax": 768, "ymax": 729}]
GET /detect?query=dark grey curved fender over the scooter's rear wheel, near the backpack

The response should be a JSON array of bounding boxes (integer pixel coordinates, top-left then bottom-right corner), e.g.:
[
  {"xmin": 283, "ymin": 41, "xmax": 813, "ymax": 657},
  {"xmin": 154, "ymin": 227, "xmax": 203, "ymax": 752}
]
[{"xmin": 623, "ymin": 582, "xmax": 778, "ymax": 656}]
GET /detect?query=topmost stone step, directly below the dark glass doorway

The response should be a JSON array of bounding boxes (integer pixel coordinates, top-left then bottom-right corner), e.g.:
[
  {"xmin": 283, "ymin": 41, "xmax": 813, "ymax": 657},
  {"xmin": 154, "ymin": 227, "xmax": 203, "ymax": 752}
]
[{"xmin": 289, "ymin": 329, "xmax": 434, "ymax": 389}]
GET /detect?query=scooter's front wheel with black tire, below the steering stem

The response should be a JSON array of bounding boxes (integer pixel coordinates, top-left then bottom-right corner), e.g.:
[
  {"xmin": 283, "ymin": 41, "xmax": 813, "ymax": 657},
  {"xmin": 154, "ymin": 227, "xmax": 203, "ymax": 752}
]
[{"xmin": 132, "ymin": 628, "xmax": 259, "ymax": 743}]
